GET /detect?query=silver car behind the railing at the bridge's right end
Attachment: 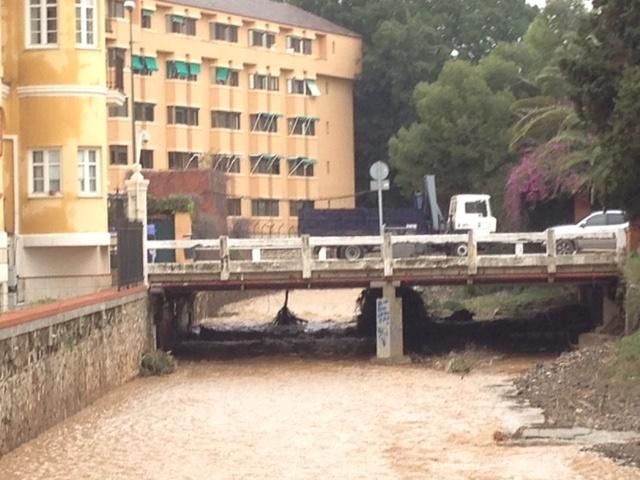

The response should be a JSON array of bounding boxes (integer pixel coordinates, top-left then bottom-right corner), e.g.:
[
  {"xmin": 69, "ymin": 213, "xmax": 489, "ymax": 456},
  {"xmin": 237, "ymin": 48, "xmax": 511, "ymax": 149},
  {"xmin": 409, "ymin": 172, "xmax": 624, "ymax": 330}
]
[{"xmin": 553, "ymin": 210, "xmax": 629, "ymax": 255}]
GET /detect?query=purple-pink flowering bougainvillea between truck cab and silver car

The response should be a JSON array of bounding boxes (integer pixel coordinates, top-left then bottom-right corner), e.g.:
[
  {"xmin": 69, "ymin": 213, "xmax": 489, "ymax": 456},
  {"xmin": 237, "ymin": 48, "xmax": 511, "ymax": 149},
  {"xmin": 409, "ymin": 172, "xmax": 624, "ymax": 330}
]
[{"xmin": 505, "ymin": 143, "xmax": 583, "ymax": 228}]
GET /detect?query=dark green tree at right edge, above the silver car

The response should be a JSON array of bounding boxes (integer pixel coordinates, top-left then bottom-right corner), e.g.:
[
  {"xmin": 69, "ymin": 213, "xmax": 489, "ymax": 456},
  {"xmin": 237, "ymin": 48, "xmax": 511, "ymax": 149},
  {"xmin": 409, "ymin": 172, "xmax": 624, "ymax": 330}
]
[{"xmin": 562, "ymin": 0, "xmax": 640, "ymax": 219}]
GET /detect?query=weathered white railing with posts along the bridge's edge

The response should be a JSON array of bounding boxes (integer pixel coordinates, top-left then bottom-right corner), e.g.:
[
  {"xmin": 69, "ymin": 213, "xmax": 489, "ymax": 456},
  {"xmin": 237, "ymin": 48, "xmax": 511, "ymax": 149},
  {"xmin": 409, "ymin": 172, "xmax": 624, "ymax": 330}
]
[{"xmin": 147, "ymin": 229, "xmax": 626, "ymax": 280}]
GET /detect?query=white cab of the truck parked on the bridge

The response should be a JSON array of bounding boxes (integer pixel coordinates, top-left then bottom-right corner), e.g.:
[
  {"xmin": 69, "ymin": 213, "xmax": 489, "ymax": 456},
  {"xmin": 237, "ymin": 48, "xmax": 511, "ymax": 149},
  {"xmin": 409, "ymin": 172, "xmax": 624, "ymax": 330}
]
[{"xmin": 447, "ymin": 194, "xmax": 497, "ymax": 234}]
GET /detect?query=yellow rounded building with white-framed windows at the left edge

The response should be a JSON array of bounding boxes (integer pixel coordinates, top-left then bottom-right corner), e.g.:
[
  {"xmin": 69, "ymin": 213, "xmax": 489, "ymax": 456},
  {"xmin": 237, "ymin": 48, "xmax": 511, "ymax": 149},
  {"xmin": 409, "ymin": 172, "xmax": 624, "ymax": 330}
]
[{"xmin": 0, "ymin": 0, "xmax": 111, "ymax": 308}]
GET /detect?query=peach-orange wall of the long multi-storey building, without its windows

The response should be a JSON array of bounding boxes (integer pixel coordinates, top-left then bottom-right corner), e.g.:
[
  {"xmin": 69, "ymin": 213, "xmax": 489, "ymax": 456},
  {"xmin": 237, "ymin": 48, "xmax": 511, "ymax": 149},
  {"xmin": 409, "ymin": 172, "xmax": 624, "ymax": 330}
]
[{"xmin": 107, "ymin": 1, "xmax": 361, "ymax": 234}]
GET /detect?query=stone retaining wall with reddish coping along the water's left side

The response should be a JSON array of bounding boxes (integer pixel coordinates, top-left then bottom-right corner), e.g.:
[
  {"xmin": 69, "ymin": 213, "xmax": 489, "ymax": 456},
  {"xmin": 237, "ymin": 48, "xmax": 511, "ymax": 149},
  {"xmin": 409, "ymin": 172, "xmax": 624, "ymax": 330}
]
[{"xmin": 0, "ymin": 288, "xmax": 154, "ymax": 456}]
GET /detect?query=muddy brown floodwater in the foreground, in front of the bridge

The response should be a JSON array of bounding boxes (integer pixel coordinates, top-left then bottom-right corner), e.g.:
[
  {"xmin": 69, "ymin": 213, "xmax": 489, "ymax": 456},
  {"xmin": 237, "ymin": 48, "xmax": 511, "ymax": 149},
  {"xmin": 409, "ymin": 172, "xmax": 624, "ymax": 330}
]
[{"xmin": 0, "ymin": 358, "xmax": 640, "ymax": 480}]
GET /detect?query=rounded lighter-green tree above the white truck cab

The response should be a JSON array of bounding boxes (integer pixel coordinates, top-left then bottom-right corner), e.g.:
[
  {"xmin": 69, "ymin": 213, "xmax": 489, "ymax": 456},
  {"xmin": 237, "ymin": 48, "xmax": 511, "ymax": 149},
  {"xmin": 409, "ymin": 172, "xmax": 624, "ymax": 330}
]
[{"xmin": 389, "ymin": 60, "xmax": 514, "ymax": 202}]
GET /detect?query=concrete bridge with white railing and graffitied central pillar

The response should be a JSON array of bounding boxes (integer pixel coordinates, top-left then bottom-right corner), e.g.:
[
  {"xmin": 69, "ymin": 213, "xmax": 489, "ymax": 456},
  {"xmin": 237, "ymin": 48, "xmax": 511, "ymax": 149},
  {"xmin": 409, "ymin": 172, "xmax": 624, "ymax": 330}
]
[{"xmin": 147, "ymin": 229, "xmax": 626, "ymax": 358}]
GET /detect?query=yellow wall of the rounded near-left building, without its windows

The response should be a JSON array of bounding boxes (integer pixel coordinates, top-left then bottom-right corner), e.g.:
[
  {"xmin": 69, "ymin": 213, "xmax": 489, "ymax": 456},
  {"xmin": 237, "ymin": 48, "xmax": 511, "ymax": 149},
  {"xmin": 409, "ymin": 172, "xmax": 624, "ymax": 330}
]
[{"xmin": 0, "ymin": 1, "xmax": 108, "ymax": 234}]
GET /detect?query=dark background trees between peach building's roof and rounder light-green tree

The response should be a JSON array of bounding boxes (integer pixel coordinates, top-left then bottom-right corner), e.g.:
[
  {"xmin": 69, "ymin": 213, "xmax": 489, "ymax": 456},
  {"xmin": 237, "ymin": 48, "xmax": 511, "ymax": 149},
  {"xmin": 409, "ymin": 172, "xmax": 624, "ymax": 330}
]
[{"xmin": 289, "ymin": 0, "xmax": 536, "ymax": 199}]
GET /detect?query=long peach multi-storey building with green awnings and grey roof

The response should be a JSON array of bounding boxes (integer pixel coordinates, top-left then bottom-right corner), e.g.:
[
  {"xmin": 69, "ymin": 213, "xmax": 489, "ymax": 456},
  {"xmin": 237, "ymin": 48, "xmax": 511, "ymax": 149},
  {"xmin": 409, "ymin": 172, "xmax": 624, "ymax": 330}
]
[{"xmin": 106, "ymin": 0, "xmax": 361, "ymax": 235}]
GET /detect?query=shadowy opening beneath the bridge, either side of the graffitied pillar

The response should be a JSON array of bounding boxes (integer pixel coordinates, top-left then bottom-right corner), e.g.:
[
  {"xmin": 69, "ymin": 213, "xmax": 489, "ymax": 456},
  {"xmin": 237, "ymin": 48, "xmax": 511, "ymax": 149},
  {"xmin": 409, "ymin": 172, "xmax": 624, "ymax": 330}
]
[{"xmin": 176, "ymin": 286, "xmax": 595, "ymax": 358}]
